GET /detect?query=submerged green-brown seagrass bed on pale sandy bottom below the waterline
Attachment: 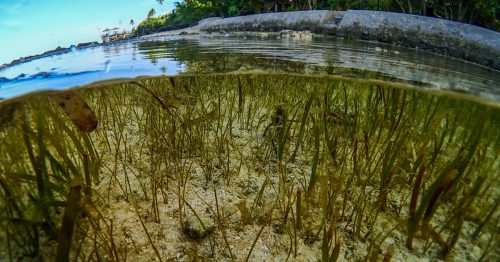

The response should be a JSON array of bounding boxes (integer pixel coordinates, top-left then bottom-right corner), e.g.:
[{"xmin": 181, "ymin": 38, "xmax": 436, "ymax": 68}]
[{"xmin": 0, "ymin": 74, "xmax": 500, "ymax": 261}]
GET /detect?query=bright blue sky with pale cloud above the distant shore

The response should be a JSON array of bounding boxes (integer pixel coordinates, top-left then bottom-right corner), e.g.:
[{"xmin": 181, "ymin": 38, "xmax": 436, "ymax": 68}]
[{"xmin": 0, "ymin": 0, "xmax": 176, "ymax": 65}]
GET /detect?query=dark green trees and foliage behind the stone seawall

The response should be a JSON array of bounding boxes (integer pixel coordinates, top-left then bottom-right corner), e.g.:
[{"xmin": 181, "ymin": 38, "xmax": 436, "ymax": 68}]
[{"xmin": 131, "ymin": 0, "xmax": 500, "ymax": 35}]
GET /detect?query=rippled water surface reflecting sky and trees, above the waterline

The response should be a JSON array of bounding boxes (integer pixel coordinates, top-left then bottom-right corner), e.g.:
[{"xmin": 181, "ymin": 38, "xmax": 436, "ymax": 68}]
[{"xmin": 0, "ymin": 36, "xmax": 500, "ymax": 101}]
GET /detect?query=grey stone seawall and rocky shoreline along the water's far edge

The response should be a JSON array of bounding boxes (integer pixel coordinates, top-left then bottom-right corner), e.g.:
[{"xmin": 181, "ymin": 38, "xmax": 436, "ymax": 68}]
[{"xmin": 0, "ymin": 10, "xmax": 500, "ymax": 70}]
